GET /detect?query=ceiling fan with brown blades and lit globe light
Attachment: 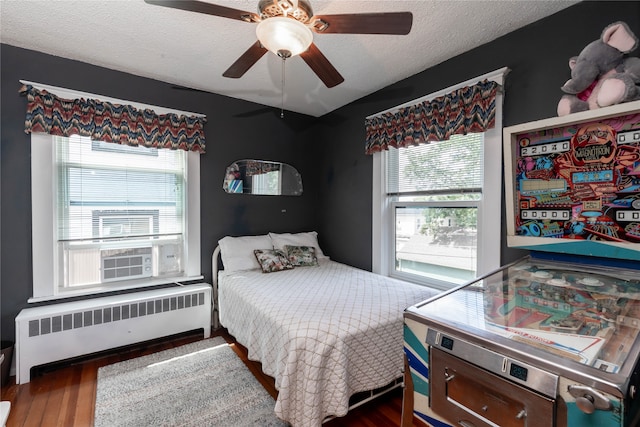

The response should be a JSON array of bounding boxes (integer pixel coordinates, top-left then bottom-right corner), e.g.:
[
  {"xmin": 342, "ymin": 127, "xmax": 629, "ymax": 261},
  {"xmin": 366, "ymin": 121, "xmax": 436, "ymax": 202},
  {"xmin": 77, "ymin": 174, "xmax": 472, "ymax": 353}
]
[{"xmin": 145, "ymin": 0, "xmax": 413, "ymax": 88}]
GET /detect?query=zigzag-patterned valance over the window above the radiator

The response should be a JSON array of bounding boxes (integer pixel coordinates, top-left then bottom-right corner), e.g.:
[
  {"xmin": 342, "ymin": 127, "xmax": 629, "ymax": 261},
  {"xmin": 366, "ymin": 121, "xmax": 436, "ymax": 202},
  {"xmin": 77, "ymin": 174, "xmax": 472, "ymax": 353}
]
[{"xmin": 20, "ymin": 85, "xmax": 207, "ymax": 153}]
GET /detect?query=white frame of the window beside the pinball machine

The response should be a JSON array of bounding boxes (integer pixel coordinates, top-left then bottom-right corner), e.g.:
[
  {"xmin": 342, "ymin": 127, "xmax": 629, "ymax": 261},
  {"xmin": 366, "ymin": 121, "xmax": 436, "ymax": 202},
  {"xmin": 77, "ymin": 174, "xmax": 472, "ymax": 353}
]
[{"xmin": 372, "ymin": 68, "xmax": 508, "ymax": 289}]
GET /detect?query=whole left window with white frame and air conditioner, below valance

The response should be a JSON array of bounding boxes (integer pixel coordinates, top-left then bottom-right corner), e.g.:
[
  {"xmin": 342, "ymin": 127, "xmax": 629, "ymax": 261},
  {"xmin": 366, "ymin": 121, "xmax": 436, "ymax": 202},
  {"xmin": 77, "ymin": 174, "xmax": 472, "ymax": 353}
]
[{"xmin": 31, "ymin": 133, "xmax": 200, "ymax": 300}]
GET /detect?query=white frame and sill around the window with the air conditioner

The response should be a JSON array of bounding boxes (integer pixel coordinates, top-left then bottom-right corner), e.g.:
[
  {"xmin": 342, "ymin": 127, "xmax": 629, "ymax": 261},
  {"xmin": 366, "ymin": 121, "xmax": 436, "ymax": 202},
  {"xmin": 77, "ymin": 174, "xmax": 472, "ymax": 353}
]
[{"xmin": 28, "ymin": 133, "xmax": 203, "ymax": 303}]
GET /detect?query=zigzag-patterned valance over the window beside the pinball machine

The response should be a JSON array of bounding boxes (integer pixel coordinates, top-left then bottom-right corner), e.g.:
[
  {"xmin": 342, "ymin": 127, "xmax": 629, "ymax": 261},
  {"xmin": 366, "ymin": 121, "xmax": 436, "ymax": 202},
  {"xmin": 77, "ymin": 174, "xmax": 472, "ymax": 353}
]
[{"xmin": 365, "ymin": 80, "xmax": 498, "ymax": 154}]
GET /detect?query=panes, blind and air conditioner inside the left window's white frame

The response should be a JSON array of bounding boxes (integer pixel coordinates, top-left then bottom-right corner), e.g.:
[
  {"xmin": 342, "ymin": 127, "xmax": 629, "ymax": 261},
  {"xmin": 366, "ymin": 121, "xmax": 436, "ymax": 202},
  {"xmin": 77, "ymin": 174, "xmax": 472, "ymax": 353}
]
[{"xmin": 53, "ymin": 135, "xmax": 187, "ymax": 287}]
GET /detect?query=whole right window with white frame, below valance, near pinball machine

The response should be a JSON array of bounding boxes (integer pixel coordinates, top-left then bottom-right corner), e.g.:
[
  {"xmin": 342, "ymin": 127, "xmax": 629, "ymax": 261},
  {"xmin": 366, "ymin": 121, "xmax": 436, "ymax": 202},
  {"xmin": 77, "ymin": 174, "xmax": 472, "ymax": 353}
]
[{"xmin": 373, "ymin": 75, "xmax": 502, "ymax": 289}]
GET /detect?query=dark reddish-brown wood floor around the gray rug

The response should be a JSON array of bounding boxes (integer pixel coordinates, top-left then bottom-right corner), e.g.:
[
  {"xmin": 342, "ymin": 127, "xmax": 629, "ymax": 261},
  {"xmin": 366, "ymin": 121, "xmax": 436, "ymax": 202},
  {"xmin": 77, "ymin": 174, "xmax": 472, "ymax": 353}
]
[{"xmin": 2, "ymin": 331, "xmax": 416, "ymax": 427}]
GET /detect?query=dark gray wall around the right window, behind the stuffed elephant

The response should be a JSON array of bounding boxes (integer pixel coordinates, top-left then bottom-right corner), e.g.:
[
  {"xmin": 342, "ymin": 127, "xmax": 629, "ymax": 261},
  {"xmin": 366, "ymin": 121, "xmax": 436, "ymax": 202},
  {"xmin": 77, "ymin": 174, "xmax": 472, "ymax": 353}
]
[{"xmin": 318, "ymin": 1, "xmax": 640, "ymax": 270}]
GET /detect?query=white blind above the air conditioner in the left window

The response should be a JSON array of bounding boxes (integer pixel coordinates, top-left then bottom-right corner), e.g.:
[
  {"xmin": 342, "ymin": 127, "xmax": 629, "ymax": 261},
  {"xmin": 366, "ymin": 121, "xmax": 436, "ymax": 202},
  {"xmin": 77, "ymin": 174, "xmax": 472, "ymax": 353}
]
[{"xmin": 55, "ymin": 136, "xmax": 186, "ymax": 243}]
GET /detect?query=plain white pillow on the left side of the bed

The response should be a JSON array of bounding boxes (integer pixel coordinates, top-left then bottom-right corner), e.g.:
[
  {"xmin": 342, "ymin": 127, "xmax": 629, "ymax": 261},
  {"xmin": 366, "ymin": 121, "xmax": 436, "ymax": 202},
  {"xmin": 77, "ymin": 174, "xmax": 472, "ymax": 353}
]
[{"xmin": 218, "ymin": 234, "xmax": 273, "ymax": 273}]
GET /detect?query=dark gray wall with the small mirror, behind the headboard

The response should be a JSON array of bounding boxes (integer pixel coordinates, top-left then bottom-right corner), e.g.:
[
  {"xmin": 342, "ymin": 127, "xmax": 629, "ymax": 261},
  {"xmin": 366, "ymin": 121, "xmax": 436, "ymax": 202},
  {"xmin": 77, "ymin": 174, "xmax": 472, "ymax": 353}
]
[{"xmin": 0, "ymin": 45, "xmax": 318, "ymax": 340}]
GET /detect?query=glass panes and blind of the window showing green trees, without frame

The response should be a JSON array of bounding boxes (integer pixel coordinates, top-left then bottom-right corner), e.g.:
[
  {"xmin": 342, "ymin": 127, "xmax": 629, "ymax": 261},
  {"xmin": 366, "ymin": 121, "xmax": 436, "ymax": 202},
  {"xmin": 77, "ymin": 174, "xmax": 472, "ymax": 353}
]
[{"xmin": 385, "ymin": 133, "xmax": 484, "ymax": 285}]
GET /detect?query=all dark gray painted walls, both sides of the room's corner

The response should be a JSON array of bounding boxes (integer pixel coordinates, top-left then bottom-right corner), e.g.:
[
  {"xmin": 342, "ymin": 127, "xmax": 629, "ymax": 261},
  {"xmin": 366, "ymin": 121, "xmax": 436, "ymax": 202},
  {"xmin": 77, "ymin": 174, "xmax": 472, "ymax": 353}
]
[{"xmin": 0, "ymin": 2, "xmax": 640, "ymax": 340}]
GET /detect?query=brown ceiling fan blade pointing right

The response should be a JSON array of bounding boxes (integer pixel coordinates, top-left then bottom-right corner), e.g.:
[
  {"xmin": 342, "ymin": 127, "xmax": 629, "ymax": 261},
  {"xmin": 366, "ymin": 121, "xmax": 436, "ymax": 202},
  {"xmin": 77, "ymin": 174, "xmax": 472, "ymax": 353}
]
[{"xmin": 310, "ymin": 12, "xmax": 413, "ymax": 35}]
